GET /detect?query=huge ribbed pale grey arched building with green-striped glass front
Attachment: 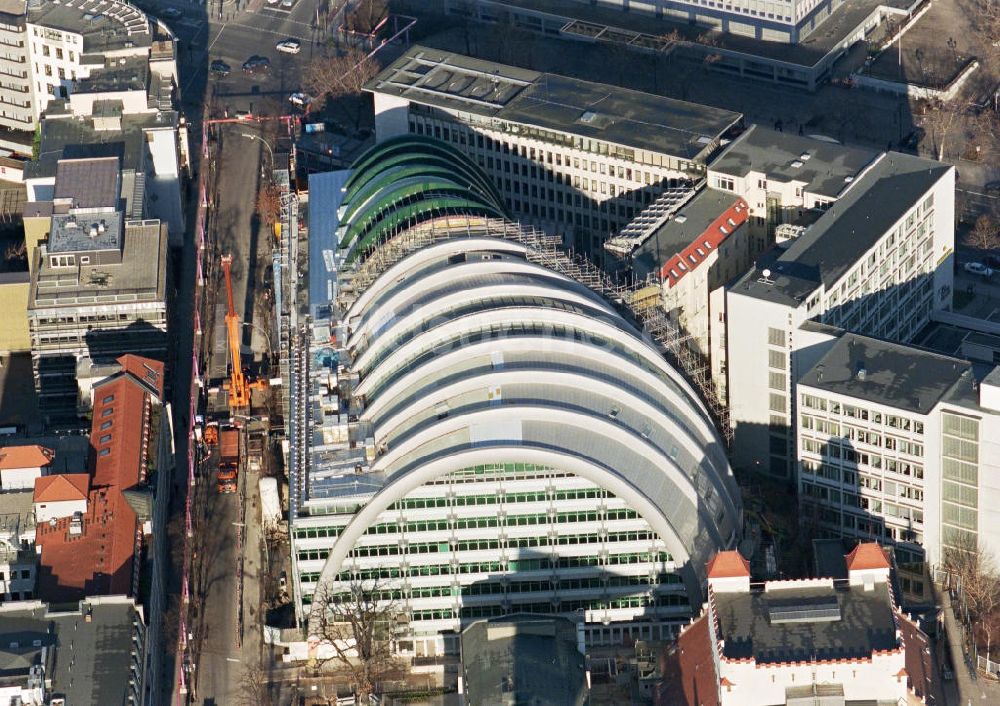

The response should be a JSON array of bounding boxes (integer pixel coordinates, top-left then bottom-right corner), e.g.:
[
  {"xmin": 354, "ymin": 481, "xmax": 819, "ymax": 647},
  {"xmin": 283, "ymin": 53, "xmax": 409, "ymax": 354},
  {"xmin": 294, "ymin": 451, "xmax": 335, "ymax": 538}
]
[{"xmin": 293, "ymin": 135, "xmax": 741, "ymax": 654}]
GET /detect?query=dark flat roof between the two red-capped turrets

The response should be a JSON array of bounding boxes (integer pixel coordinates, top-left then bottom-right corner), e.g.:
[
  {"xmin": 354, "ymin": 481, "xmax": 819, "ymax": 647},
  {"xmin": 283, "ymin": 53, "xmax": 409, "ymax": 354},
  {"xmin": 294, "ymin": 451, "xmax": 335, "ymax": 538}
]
[{"xmin": 713, "ymin": 581, "xmax": 898, "ymax": 664}]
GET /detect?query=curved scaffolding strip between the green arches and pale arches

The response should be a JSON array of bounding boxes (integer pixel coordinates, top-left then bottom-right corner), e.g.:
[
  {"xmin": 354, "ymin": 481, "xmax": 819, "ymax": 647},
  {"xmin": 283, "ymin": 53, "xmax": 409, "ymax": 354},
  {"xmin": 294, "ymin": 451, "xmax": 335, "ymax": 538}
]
[{"xmin": 337, "ymin": 216, "xmax": 733, "ymax": 447}]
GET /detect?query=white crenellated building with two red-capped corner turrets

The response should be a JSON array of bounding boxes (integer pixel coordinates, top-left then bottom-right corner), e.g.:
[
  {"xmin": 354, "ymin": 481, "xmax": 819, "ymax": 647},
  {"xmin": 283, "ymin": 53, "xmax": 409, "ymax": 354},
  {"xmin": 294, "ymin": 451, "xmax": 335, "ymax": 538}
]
[{"xmin": 660, "ymin": 543, "xmax": 942, "ymax": 706}]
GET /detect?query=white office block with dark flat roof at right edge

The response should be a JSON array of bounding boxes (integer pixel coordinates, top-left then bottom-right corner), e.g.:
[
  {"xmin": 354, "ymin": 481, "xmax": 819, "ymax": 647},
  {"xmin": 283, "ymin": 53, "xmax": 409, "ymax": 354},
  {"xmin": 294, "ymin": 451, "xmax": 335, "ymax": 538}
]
[{"xmin": 796, "ymin": 333, "xmax": 1000, "ymax": 564}]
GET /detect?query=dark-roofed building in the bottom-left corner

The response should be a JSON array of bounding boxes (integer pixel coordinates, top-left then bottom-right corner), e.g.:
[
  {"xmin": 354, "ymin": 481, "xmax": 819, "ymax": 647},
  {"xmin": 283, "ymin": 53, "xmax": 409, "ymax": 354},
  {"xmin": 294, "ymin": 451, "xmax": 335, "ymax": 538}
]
[{"xmin": 0, "ymin": 596, "xmax": 148, "ymax": 706}]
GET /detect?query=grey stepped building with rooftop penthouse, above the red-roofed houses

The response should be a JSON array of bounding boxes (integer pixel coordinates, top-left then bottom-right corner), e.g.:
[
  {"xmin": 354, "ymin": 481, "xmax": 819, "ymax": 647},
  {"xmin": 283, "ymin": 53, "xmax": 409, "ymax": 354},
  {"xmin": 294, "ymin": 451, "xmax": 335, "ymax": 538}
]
[{"xmin": 28, "ymin": 157, "xmax": 169, "ymax": 420}]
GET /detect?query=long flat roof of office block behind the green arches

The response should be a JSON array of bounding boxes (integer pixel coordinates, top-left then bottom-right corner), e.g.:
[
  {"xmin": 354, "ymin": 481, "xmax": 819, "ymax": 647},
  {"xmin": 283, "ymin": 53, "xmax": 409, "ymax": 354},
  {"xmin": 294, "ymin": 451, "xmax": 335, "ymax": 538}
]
[{"xmin": 365, "ymin": 45, "xmax": 742, "ymax": 160}]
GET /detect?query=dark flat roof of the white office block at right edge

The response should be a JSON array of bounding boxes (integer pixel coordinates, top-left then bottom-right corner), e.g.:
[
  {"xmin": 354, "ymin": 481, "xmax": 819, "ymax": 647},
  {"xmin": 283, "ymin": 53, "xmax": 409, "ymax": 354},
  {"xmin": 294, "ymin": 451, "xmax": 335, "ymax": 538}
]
[{"xmin": 799, "ymin": 333, "xmax": 974, "ymax": 414}]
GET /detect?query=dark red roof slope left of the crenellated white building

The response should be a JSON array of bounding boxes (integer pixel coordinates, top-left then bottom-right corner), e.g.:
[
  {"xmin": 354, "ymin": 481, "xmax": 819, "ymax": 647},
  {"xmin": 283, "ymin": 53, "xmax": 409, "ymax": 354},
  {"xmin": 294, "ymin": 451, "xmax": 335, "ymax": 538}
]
[{"xmin": 654, "ymin": 615, "xmax": 720, "ymax": 706}]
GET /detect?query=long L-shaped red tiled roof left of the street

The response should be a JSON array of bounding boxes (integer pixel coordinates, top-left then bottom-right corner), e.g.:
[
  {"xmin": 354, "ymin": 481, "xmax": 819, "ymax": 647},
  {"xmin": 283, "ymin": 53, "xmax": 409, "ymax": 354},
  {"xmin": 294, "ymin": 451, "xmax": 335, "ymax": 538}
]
[{"xmin": 37, "ymin": 364, "xmax": 154, "ymax": 602}]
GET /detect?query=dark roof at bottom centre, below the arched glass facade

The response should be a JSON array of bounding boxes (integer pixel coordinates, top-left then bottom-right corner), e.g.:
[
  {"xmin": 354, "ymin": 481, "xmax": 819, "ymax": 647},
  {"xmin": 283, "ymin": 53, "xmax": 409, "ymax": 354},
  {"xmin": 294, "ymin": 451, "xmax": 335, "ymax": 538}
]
[{"xmin": 462, "ymin": 614, "xmax": 587, "ymax": 706}]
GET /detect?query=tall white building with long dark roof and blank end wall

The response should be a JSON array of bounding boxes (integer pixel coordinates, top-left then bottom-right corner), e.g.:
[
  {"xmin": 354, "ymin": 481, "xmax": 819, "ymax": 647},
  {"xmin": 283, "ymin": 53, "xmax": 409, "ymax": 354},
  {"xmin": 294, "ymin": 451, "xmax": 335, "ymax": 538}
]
[{"xmin": 726, "ymin": 152, "xmax": 955, "ymax": 481}]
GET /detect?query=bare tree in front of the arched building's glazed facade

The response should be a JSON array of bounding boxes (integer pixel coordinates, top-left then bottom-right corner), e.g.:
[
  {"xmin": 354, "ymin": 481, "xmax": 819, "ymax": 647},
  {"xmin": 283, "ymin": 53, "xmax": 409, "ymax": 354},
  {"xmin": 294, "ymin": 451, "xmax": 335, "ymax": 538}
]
[{"xmin": 309, "ymin": 580, "xmax": 402, "ymax": 703}]
